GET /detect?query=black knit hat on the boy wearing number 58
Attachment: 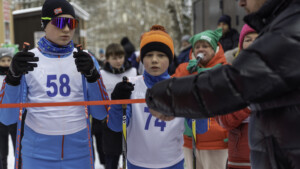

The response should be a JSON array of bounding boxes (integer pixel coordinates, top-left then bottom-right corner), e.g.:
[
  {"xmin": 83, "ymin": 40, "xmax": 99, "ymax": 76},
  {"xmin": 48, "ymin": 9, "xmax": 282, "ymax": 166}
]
[{"xmin": 42, "ymin": 0, "xmax": 75, "ymax": 29}]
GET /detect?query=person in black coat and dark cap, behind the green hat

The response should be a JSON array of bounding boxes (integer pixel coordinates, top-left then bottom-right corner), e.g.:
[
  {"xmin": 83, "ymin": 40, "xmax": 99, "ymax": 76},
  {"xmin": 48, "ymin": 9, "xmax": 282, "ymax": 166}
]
[{"xmin": 218, "ymin": 15, "xmax": 240, "ymax": 52}]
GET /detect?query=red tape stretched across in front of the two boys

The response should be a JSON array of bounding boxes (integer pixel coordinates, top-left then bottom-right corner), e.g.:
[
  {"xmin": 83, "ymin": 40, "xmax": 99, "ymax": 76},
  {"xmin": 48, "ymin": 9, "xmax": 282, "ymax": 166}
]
[{"xmin": 0, "ymin": 99, "xmax": 146, "ymax": 108}]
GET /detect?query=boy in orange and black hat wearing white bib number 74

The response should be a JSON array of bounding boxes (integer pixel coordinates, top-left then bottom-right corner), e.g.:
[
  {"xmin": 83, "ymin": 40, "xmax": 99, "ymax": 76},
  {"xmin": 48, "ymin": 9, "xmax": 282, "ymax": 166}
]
[{"xmin": 103, "ymin": 25, "xmax": 208, "ymax": 169}]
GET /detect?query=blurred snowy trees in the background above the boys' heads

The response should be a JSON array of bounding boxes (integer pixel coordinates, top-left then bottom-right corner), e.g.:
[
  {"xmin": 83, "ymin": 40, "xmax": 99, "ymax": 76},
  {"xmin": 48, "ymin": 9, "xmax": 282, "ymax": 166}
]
[{"xmin": 73, "ymin": 0, "xmax": 192, "ymax": 57}]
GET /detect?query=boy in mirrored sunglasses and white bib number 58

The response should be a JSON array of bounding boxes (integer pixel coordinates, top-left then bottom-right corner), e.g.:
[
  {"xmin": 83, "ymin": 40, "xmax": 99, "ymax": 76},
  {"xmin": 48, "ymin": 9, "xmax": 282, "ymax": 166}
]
[{"xmin": 0, "ymin": 0, "xmax": 108, "ymax": 169}]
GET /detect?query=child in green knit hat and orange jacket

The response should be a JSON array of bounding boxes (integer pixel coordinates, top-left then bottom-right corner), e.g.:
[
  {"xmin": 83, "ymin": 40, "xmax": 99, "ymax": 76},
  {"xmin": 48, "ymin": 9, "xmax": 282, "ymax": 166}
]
[{"xmin": 172, "ymin": 29, "xmax": 228, "ymax": 169}]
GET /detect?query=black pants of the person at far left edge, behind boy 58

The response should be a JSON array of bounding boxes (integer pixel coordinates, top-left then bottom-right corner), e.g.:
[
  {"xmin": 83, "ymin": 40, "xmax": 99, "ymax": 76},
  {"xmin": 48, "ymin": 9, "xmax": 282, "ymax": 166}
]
[{"xmin": 0, "ymin": 123, "xmax": 17, "ymax": 169}]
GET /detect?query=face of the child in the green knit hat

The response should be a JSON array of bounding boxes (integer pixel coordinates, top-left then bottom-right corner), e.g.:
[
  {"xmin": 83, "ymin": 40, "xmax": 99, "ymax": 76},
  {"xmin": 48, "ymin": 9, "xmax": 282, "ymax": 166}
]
[{"xmin": 194, "ymin": 40, "xmax": 215, "ymax": 66}]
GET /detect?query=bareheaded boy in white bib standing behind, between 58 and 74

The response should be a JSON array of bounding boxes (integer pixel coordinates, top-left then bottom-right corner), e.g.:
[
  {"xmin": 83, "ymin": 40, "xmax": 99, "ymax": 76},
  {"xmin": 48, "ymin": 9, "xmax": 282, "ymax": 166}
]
[{"xmin": 98, "ymin": 43, "xmax": 137, "ymax": 169}]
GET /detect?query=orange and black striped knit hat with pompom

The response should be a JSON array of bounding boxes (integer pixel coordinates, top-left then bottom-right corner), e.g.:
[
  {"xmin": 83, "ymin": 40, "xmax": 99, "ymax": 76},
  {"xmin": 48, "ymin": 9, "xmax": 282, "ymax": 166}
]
[{"xmin": 140, "ymin": 25, "xmax": 174, "ymax": 64}]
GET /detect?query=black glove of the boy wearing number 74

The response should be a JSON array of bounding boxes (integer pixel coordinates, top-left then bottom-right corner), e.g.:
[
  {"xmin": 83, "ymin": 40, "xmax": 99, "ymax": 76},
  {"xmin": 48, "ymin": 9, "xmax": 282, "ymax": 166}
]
[{"xmin": 111, "ymin": 81, "xmax": 134, "ymax": 100}]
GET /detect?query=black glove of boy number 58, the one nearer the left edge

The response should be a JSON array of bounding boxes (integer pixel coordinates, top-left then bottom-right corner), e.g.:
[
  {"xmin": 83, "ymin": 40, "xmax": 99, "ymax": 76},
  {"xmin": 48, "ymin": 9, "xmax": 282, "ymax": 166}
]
[{"xmin": 5, "ymin": 52, "xmax": 39, "ymax": 86}]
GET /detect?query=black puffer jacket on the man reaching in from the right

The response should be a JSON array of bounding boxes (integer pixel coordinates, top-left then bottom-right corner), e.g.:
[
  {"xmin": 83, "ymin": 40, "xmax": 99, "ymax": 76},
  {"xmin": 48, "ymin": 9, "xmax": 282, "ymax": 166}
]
[{"xmin": 146, "ymin": 0, "xmax": 300, "ymax": 169}]
